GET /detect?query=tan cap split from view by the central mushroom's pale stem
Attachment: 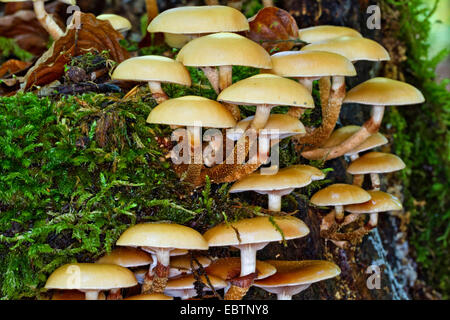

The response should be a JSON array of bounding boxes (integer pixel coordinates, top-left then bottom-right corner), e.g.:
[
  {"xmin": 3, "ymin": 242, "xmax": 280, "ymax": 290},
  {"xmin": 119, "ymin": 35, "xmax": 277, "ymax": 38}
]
[{"xmin": 227, "ymin": 113, "xmax": 306, "ymax": 141}]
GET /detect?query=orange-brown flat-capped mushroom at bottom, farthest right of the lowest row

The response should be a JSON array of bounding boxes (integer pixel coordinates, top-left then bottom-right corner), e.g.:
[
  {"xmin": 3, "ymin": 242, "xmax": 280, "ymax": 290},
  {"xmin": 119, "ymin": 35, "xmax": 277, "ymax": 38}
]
[{"xmin": 254, "ymin": 260, "xmax": 341, "ymax": 300}]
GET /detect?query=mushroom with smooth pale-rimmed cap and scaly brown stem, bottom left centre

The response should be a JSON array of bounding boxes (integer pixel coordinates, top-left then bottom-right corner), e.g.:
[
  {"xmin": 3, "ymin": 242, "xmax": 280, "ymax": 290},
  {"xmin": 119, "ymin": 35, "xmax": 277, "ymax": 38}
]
[{"xmin": 116, "ymin": 223, "xmax": 208, "ymax": 293}]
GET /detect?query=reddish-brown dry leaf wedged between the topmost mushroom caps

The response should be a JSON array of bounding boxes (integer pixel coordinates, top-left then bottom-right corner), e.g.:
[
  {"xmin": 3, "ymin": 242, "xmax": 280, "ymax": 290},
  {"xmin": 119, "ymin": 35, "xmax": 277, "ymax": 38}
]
[{"xmin": 248, "ymin": 7, "xmax": 298, "ymax": 53}]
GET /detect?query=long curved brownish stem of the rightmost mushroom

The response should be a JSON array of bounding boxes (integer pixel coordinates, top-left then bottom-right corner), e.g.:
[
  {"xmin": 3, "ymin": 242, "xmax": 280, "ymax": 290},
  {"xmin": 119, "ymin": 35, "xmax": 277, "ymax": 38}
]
[{"xmin": 302, "ymin": 106, "xmax": 384, "ymax": 160}]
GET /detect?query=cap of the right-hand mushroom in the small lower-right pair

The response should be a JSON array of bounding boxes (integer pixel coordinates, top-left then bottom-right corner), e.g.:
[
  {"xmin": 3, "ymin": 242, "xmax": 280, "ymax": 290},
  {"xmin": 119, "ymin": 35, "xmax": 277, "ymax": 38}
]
[{"xmin": 345, "ymin": 191, "xmax": 403, "ymax": 213}]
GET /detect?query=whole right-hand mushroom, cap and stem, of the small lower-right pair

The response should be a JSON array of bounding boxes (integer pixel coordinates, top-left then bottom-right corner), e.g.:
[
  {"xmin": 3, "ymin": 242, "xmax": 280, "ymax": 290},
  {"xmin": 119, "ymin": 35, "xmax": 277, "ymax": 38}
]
[{"xmin": 343, "ymin": 190, "xmax": 403, "ymax": 231}]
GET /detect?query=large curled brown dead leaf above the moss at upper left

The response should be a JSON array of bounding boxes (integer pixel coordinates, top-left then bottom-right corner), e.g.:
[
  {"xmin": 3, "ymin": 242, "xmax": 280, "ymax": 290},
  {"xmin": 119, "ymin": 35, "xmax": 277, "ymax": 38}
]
[{"xmin": 25, "ymin": 12, "xmax": 130, "ymax": 90}]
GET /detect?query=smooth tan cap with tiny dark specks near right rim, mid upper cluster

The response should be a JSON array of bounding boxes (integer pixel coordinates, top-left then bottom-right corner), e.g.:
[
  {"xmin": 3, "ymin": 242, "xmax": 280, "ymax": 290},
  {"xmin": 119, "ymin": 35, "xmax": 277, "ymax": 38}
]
[{"xmin": 217, "ymin": 73, "xmax": 314, "ymax": 108}]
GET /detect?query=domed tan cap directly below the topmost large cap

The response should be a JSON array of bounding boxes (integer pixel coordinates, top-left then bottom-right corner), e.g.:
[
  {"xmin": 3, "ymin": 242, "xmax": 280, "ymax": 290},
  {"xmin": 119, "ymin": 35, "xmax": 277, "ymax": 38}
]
[{"xmin": 177, "ymin": 32, "xmax": 272, "ymax": 69}]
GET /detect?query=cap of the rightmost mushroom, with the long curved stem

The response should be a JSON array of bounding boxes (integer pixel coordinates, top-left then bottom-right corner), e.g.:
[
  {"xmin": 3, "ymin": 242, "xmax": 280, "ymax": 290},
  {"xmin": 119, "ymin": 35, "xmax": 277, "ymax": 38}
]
[{"xmin": 344, "ymin": 77, "xmax": 425, "ymax": 106}]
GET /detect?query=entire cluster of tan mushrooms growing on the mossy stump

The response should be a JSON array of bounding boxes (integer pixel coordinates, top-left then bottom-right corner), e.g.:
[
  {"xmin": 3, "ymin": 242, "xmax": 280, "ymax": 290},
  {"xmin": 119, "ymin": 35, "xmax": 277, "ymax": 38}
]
[{"xmin": 46, "ymin": 5, "xmax": 424, "ymax": 299}]
